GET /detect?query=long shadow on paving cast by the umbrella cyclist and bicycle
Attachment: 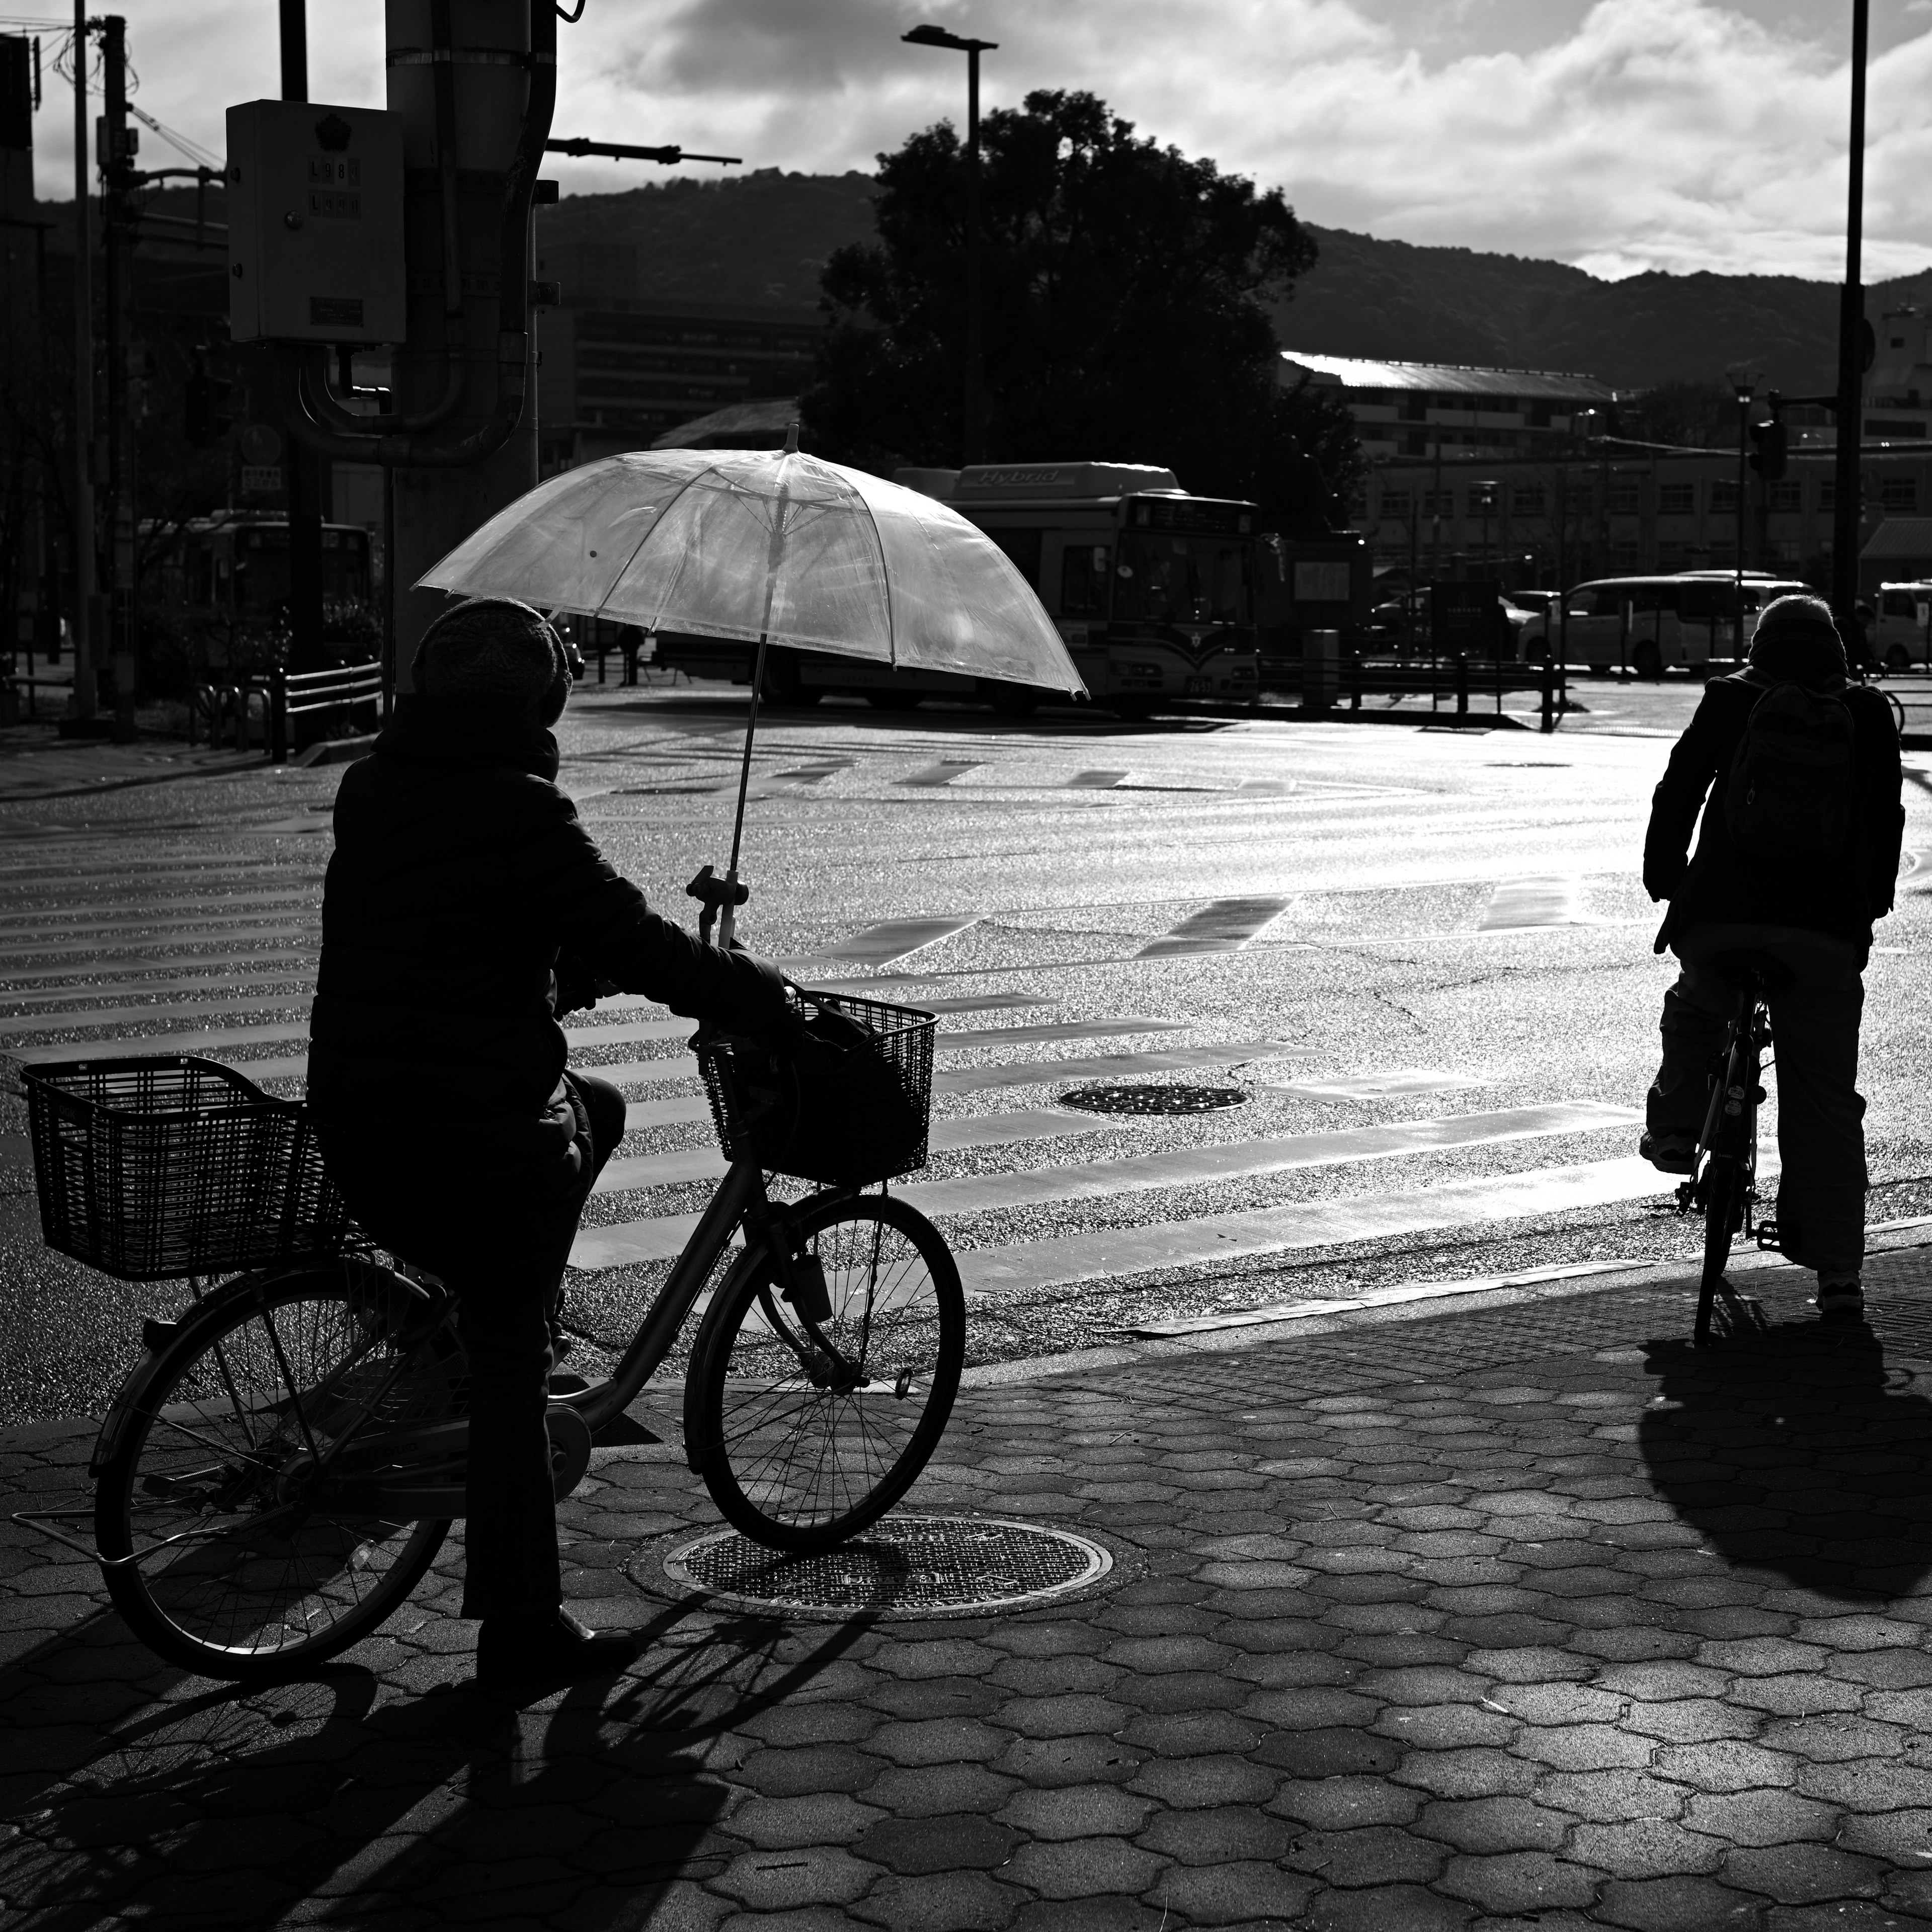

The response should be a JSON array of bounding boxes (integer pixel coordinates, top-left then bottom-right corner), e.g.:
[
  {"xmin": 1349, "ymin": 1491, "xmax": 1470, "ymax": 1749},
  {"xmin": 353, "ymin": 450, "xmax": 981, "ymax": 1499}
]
[{"xmin": 0, "ymin": 1603, "xmax": 863, "ymax": 1932}]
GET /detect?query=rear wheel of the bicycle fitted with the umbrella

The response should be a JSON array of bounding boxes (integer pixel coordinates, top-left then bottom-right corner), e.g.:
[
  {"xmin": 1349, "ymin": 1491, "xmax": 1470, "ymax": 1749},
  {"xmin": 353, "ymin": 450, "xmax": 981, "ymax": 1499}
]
[{"xmin": 95, "ymin": 1262, "xmax": 464, "ymax": 1681}]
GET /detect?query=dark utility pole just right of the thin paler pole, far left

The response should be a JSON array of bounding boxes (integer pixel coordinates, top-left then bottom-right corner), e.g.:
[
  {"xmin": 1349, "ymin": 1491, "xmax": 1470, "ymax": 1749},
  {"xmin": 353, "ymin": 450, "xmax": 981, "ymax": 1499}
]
[{"xmin": 101, "ymin": 14, "xmax": 139, "ymax": 742}]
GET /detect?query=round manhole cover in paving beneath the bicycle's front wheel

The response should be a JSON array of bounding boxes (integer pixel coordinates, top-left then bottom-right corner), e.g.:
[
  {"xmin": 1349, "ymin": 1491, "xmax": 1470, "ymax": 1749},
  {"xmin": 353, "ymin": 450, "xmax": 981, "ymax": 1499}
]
[{"xmin": 649, "ymin": 1516, "xmax": 1113, "ymax": 1621}]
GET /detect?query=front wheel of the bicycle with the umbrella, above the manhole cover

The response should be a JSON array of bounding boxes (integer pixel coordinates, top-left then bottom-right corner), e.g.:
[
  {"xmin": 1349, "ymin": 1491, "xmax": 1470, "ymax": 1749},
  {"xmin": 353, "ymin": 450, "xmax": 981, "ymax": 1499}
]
[{"xmin": 684, "ymin": 1194, "xmax": 966, "ymax": 1553}]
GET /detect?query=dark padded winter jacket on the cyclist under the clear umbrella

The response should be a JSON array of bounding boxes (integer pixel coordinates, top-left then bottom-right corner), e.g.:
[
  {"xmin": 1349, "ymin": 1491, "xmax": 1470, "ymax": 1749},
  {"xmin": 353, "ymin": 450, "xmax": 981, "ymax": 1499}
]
[{"xmin": 309, "ymin": 697, "xmax": 784, "ymax": 1138}]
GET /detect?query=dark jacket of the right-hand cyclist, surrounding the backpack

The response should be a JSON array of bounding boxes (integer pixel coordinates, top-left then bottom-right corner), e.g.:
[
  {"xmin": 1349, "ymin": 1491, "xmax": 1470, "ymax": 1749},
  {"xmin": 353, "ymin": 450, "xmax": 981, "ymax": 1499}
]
[{"xmin": 1644, "ymin": 641, "xmax": 1905, "ymax": 962}]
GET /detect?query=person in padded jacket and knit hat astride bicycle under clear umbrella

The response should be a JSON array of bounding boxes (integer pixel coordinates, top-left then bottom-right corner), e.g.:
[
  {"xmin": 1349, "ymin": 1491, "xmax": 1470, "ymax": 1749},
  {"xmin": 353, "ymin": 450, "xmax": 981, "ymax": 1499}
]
[{"xmin": 309, "ymin": 599, "xmax": 788, "ymax": 1679}]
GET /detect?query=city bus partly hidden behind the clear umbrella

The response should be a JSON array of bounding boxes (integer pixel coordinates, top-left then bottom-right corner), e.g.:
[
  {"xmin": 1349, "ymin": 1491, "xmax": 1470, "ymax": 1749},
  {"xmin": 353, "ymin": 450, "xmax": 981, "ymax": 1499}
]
[{"xmin": 655, "ymin": 462, "xmax": 1260, "ymax": 717}]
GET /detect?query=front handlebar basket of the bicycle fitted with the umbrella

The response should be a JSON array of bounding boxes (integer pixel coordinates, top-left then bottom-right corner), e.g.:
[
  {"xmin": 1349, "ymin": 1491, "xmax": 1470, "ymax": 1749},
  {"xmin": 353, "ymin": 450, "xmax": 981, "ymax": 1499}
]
[{"xmin": 692, "ymin": 993, "xmax": 937, "ymax": 1186}]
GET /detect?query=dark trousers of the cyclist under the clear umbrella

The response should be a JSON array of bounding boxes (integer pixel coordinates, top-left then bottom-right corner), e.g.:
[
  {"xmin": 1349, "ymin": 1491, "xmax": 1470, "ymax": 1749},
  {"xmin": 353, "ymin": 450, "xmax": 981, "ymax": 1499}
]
[{"xmin": 319, "ymin": 1072, "xmax": 624, "ymax": 1617}]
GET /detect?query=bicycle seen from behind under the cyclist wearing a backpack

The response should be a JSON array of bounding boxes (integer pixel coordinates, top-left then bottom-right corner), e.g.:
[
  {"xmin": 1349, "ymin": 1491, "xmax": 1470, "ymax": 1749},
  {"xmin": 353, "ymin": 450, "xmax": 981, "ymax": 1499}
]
[{"xmin": 1677, "ymin": 952, "xmax": 1789, "ymax": 1348}]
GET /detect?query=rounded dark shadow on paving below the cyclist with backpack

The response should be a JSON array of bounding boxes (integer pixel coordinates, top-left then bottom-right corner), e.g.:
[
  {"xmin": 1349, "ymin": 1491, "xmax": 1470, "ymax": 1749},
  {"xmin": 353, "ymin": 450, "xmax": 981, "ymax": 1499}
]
[{"xmin": 1636, "ymin": 1320, "xmax": 1932, "ymax": 1603}]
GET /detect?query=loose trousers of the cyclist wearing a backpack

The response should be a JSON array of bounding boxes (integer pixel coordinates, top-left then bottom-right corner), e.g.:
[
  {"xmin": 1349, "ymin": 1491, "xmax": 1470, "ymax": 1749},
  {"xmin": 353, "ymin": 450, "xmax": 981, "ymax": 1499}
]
[{"xmin": 1648, "ymin": 925, "xmax": 1868, "ymax": 1281}]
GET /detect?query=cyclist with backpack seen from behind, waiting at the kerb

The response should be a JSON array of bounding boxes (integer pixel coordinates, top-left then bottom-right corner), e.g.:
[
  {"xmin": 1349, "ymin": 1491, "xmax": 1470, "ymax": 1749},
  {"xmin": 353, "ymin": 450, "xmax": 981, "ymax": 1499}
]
[{"xmin": 1642, "ymin": 597, "xmax": 1905, "ymax": 1318}]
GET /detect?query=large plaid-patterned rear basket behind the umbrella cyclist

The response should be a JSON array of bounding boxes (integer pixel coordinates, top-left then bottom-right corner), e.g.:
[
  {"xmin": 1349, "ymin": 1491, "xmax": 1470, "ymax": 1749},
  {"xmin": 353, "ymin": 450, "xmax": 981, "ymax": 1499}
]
[{"xmin": 23, "ymin": 1055, "xmax": 348, "ymax": 1281}]
